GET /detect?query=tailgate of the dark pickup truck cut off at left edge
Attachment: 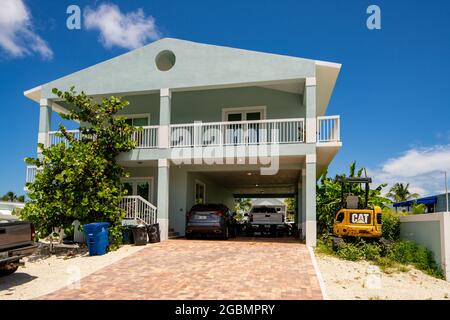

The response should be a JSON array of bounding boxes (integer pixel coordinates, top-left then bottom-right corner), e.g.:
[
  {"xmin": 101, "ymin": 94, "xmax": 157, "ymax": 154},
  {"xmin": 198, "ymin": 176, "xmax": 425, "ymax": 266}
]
[{"xmin": 0, "ymin": 221, "xmax": 32, "ymax": 251}]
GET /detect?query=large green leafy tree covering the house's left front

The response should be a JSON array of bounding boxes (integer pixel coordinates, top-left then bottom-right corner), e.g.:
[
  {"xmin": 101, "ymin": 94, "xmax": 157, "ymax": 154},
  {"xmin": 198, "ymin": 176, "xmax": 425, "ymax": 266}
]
[{"xmin": 21, "ymin": 88, "xmax": 137, "ymax": 244}]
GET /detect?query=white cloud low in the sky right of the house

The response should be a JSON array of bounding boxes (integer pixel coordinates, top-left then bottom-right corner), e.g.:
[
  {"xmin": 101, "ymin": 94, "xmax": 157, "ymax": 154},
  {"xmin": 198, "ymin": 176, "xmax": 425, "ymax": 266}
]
[{"xmin": 369, "ymin": 145, "xmax": 450, "ymax": 196}]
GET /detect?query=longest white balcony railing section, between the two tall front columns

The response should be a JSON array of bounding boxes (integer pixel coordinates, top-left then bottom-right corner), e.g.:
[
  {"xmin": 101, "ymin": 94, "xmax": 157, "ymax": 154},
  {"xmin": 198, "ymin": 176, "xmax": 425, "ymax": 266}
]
[{"xmin": 170, "ymin": 119, "xmax": 305, "ymax": 147}]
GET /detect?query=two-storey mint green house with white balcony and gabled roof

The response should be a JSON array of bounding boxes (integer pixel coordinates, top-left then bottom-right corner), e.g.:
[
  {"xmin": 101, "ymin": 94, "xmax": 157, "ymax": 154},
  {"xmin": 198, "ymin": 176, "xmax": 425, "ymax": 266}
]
[{"xmin": 24, "ymin": 38, "xmax": 342, "ymax": 245}]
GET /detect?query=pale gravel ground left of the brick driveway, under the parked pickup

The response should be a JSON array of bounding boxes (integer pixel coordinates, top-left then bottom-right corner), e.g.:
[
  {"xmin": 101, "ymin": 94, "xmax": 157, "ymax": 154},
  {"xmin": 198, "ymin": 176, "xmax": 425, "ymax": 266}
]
[{"xmin": 0, "ymin": 245, "xmax": 145, "ymax": 300}]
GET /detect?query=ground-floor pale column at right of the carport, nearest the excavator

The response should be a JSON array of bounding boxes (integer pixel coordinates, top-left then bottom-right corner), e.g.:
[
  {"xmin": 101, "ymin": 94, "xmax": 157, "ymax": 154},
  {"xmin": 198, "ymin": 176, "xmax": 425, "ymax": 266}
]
[{"xmin": 305, "ymin": 153, "xmax": 317, "ymax": 247}]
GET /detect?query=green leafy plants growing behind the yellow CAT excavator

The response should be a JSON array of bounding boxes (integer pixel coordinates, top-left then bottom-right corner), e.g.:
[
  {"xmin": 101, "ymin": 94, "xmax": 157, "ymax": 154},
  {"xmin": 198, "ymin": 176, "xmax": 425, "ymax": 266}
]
[{"xmin": 316, "ymin": 162, "xmax": 391, "ymax": 234}]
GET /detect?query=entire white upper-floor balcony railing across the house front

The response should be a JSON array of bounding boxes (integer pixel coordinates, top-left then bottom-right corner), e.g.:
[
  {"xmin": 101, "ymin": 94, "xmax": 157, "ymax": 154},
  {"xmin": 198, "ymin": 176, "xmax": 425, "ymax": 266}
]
[{"xmin": 47, "ymin": 116, "xmax": 340, "ymax": 149}]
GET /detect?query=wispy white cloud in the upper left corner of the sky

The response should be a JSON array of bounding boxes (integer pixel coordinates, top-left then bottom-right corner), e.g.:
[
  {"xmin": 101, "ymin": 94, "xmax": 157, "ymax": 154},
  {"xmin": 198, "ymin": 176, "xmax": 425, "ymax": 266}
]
[{"xmin": 0, "ymin": 0, "xmax": 53, "ymax": 59}]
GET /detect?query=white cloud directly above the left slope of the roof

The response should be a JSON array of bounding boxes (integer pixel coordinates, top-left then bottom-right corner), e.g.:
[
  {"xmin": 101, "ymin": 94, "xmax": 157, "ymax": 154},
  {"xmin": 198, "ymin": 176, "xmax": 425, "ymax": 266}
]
[{"xmin": 84, "ymin": 4, "xmax": 160, "ymax": 49}]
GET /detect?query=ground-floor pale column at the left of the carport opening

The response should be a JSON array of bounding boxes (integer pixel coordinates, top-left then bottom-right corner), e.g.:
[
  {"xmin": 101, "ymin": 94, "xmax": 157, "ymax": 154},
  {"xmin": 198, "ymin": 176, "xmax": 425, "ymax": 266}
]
[{"xmin": 157, "ymin": 159, "xmax": 170, "ymax": 240}]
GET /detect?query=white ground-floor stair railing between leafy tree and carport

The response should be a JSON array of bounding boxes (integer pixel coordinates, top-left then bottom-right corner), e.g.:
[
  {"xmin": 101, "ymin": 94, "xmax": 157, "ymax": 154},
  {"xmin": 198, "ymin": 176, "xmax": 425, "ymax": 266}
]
[{"xmin": 119, "ymin": 196, "xmax": 157, "ymax": 224}]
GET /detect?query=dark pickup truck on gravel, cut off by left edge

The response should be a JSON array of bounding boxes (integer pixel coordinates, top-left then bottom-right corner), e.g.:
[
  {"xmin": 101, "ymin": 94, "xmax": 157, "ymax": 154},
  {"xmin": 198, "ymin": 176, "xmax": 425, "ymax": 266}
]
[{"xmin": 0, "ymin": 214, "xmax": 37, "ymax": 277}]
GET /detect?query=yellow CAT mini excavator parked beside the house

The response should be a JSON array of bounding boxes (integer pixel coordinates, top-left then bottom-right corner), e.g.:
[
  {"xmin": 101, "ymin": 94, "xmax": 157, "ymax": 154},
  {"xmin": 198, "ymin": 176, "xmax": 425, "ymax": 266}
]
[{"xmin": 333, "ymin": 177, "xmax": 382, "ymax": 245}]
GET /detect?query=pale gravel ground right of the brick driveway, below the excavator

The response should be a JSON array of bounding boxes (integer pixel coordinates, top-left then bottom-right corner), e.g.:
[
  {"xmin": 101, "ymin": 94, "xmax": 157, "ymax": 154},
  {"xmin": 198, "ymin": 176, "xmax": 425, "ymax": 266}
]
[{"xmin": 316, "ymin": 253, "xmax": 450, "ymax": 300}]
